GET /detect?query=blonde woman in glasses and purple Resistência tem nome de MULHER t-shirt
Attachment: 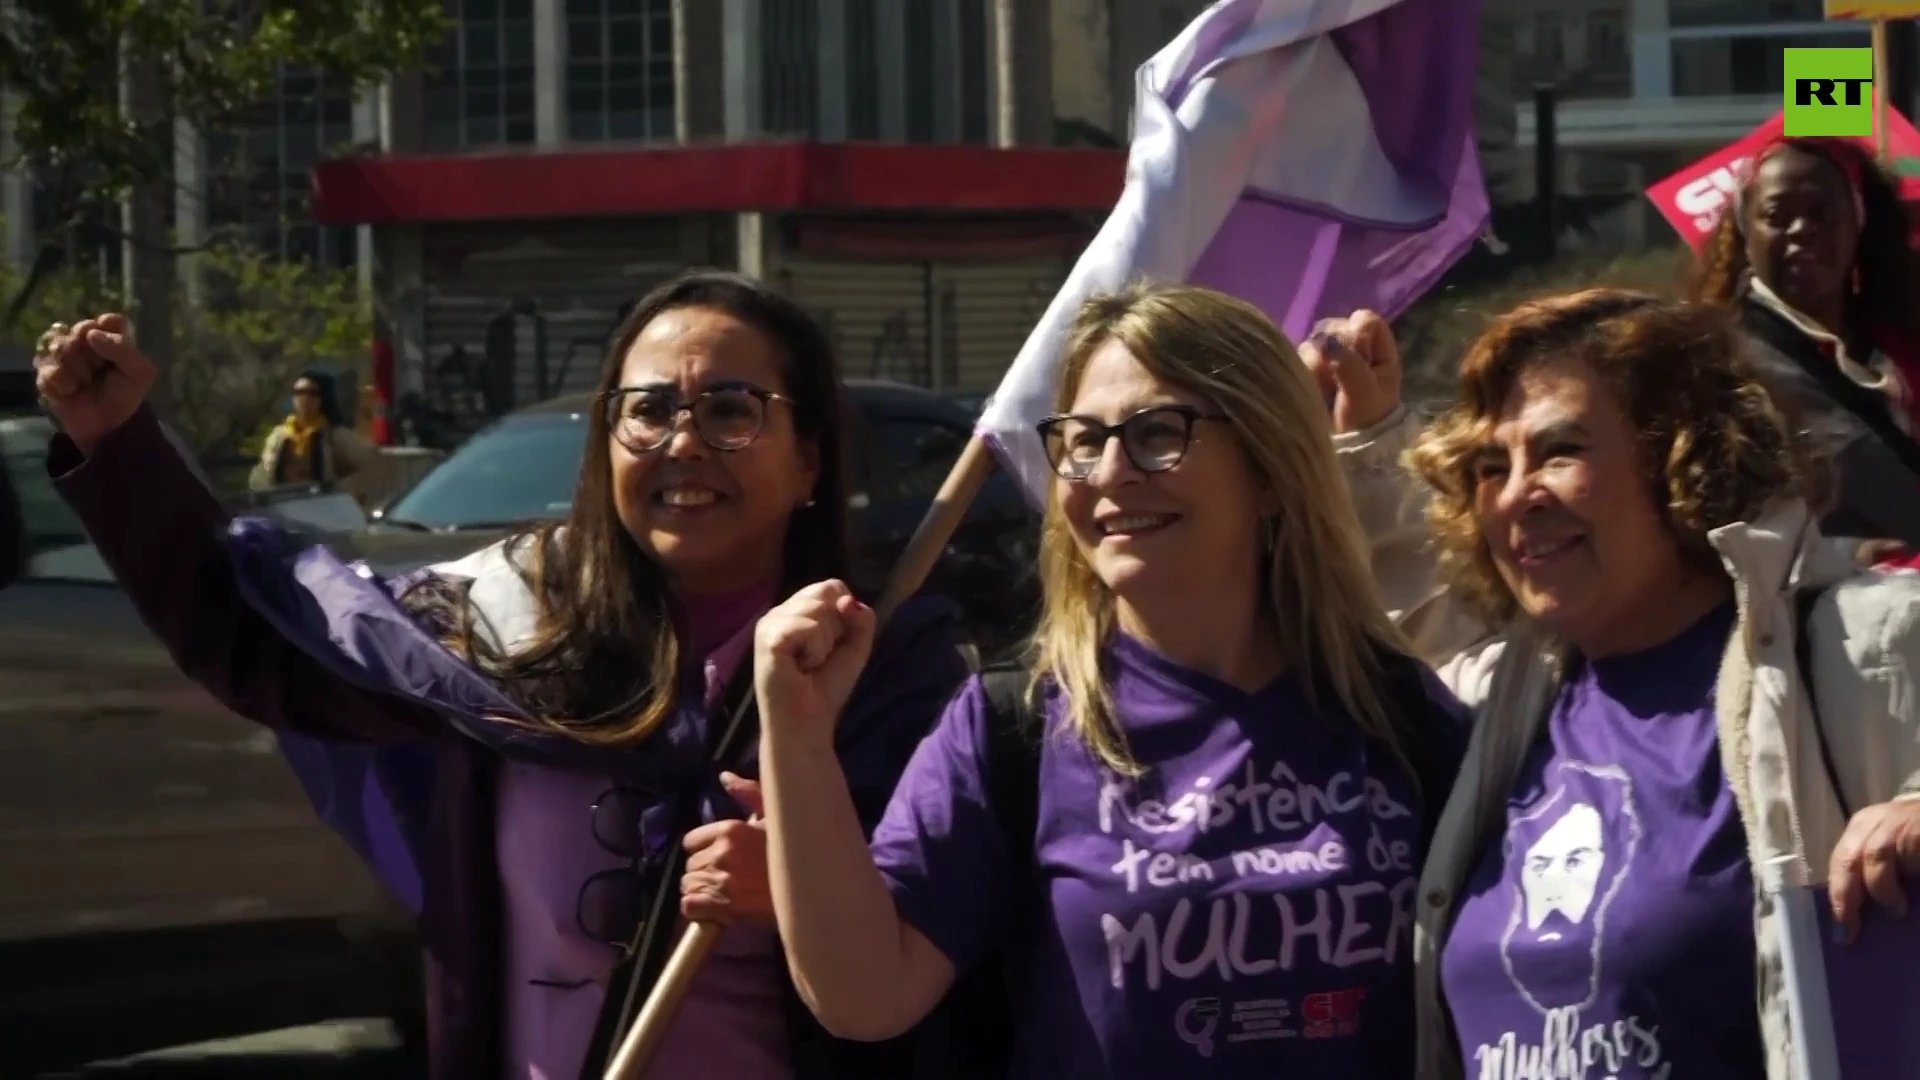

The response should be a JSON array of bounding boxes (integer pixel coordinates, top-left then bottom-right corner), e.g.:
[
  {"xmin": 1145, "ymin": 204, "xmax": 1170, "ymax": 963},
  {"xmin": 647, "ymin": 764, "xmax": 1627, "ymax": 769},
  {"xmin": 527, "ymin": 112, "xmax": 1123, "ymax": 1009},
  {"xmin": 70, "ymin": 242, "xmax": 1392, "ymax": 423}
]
[{"xmin": 755, "ymin": 286, "xmax": 1463, "ymax": 1080}]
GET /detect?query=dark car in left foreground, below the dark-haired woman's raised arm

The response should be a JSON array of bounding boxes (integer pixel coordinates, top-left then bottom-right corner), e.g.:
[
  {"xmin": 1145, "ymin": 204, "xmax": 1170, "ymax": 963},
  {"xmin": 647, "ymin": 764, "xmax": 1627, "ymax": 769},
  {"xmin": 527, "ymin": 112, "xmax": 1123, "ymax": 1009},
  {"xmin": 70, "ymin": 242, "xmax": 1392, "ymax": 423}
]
[{"xmin": 0, "ymin": 415, "xmax": 422, "ymax": 1076}]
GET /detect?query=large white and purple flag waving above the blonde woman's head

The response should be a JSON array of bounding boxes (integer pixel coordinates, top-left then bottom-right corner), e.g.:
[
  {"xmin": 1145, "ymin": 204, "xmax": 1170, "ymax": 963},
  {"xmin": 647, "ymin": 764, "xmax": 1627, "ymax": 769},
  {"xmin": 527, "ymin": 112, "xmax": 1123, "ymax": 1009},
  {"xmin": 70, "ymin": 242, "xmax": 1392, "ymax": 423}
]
[{"xmin": 977, "ymin": 0, "xmax": 1488, "ymax": 502}]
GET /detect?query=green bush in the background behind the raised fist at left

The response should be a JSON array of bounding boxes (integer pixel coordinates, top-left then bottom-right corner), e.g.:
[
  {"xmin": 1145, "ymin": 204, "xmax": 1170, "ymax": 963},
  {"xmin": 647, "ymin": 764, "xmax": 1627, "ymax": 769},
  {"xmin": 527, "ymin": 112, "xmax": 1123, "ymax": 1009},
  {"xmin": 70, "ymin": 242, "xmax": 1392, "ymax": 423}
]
[{"xmin": 0, "ymin": 220, "xmax": 372, "ymax": 457}]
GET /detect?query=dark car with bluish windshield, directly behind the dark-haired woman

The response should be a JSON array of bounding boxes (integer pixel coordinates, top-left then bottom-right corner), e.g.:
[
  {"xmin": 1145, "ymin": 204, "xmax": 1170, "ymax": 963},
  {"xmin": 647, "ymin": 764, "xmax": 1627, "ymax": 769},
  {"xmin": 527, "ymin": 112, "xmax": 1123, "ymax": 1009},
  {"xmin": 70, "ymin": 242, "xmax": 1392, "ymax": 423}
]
[{"xmin": 345, "ymin": 380, "xmax": 1037, "ymax": 655}]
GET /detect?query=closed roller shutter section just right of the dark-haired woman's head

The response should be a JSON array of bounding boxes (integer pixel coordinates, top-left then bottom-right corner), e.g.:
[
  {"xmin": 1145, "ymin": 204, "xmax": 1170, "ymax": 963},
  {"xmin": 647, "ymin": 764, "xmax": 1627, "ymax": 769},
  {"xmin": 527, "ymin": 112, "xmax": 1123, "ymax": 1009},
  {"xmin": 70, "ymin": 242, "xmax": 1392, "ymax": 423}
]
[{"xmin": 780, "ymin": 258, "xmax": 937, "ymax": 386}]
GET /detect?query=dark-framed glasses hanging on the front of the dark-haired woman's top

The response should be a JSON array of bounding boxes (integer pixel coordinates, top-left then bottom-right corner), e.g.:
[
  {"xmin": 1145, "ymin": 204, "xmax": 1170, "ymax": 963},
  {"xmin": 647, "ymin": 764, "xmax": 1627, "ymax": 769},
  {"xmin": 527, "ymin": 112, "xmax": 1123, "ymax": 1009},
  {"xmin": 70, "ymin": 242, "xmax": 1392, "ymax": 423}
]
[{"xmin": 534, "ymin": 788, "xmax": 678, "ymax": 990}]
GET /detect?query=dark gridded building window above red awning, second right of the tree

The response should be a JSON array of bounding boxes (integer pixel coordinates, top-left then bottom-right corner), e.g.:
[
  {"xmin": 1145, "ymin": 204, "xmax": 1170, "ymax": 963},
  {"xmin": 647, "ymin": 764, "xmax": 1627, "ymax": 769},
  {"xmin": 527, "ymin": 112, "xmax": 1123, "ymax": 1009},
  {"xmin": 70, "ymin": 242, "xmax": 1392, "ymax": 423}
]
[{"xmin": 566, "ymin": 0, "xmax": 674, "ymax": 142}]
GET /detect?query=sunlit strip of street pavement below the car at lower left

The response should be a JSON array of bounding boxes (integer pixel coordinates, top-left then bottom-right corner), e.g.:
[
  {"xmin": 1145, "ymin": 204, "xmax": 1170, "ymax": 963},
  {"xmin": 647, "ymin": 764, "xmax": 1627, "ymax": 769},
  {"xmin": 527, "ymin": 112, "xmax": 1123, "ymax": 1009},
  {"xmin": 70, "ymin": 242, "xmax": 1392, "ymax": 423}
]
[{"xmin": 38, "ymin": 1020, "xmax": 420, "ymax": 1080}]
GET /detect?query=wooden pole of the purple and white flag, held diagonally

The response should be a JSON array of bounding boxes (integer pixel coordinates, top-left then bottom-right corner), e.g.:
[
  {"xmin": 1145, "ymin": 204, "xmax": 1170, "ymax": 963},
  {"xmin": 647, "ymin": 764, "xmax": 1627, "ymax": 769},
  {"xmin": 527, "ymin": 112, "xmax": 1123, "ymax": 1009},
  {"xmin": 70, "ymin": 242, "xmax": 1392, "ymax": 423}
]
[{"xmin": 607, "ymin": 434, "xmax": 996, "ymax": 1080}]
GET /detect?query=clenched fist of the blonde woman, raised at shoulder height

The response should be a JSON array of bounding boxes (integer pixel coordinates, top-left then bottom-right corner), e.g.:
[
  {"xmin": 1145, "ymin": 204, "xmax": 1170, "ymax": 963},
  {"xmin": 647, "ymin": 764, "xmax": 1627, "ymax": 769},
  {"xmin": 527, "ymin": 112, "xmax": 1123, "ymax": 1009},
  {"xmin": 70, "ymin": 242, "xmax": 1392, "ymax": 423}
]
[{"xmin": 753, "ymin": 580, "xmax": 876, "ymax": 746}]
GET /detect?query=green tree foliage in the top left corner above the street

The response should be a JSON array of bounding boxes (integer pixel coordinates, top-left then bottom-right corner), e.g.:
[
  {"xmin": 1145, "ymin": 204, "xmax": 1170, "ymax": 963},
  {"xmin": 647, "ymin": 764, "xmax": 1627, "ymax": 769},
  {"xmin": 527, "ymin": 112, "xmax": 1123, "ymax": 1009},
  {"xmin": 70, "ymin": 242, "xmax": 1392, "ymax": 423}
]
[{"xmin": 0, "ymin": 0, "xmax": 449, "ymax": 192}]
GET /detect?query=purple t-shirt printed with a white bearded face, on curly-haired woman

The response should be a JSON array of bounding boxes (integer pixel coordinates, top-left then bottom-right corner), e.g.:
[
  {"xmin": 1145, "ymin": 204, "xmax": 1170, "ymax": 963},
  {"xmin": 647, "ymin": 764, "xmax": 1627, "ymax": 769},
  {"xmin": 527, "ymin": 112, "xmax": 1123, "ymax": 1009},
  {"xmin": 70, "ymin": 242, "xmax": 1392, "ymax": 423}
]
[{"xmin": 1440, "ymin": 605, "xmax": 1766, "ymax": 1080}]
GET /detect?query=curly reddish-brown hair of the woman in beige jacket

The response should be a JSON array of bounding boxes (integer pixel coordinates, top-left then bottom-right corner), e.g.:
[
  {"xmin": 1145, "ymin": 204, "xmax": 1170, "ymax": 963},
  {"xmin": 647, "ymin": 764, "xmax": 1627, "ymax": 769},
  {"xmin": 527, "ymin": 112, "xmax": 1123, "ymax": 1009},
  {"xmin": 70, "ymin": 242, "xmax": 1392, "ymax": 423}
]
[{"xmin": 1407, "ymin": 288, "xmax": 1824, "ymax": 625}]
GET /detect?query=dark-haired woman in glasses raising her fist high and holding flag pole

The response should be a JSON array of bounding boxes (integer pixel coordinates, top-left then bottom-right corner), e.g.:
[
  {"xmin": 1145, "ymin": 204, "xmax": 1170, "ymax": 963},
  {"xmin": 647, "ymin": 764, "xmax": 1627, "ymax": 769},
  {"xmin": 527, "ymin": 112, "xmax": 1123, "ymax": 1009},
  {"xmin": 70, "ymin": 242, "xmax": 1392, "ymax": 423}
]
[{"xmin": 36, "ymin": 273, "xmax": 966, "ymax": 1080}]
